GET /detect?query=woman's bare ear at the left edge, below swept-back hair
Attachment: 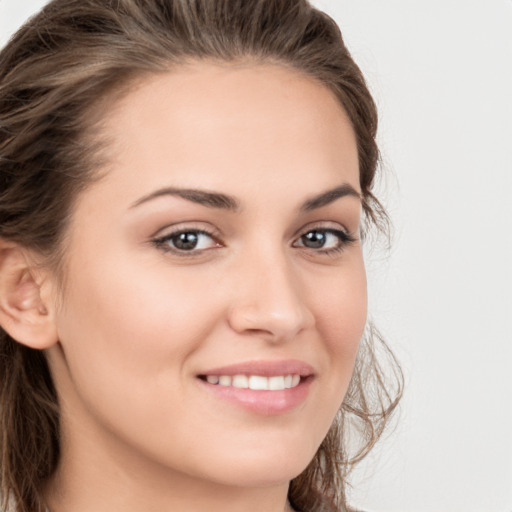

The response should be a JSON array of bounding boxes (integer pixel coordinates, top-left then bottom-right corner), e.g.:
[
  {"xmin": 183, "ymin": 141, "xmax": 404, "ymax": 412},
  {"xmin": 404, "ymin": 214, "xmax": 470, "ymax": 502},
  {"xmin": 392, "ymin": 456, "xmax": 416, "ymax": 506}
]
[{"xmin": 0, "ymin": 240, "xmax": 58, "ymax": 350}]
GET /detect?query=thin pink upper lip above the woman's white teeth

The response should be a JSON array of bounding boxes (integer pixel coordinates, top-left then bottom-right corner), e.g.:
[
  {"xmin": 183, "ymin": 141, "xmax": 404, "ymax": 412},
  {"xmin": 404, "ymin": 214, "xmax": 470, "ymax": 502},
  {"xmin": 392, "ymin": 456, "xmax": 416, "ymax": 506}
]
[{"xmin": 199, "ymin": 359, "xmax": 315, "ymax": 377}]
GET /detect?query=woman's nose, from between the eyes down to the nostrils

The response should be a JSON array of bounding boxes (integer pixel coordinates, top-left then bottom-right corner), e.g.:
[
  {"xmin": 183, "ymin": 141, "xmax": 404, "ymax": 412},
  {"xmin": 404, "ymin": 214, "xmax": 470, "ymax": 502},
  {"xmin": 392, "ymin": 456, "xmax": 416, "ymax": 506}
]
[{"xmin": 229, "ymin": 250, "xmax": 315, "ymax": 343}]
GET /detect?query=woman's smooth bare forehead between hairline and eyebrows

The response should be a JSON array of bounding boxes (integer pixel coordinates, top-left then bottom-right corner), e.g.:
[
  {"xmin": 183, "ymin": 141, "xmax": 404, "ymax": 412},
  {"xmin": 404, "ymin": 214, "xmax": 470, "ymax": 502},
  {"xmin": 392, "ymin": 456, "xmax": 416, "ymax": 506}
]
[{"xmin": 86, "ymin": 62, "xmax": 359, "ymax": 207}]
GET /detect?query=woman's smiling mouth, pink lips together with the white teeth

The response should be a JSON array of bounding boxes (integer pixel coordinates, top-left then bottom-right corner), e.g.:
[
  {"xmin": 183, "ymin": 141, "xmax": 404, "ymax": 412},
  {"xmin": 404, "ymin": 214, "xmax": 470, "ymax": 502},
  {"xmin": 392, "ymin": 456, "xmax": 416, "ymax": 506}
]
[{"xmin": 197, "ymin": 361, "xmax": 315, "ymax": 416}]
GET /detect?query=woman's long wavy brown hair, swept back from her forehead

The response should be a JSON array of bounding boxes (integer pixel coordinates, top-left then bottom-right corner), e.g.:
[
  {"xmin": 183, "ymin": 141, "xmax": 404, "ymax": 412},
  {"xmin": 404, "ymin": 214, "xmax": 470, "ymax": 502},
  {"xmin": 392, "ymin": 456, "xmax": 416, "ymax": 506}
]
[{"xmin": 0, "ymin": 0, "xmax": 402, "ymax": 512}]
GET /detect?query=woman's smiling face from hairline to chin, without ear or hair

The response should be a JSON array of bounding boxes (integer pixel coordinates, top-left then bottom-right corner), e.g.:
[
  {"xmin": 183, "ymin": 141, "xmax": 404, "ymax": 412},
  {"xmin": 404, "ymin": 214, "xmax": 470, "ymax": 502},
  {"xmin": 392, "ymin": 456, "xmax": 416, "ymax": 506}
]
[{"xmin": 48, "ymin": 63, "xmax": 366, "ymax": 486}]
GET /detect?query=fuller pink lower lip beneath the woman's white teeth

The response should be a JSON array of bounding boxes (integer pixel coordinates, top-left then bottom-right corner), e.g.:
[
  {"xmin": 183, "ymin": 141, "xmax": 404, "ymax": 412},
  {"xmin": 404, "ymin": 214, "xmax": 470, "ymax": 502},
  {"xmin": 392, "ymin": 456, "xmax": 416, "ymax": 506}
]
[{"xmin": 199, "ymin": 377, "xmax": 313, "ymax": 416}]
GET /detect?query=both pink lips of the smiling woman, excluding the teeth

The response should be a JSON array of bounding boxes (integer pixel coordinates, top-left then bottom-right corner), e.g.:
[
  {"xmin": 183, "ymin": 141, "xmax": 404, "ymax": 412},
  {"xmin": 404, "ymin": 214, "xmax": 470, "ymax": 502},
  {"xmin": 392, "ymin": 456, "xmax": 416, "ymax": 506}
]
[{"xmin": 198, "ymin": 360, "xmax": 314, "ymax": 416}]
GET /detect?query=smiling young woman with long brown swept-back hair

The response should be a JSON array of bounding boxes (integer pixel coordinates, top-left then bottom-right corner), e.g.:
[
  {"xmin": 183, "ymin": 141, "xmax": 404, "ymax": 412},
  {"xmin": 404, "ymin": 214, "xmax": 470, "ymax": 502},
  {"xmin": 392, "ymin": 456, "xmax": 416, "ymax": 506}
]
[{"xmin": 0, "ymin": 0, "xmax": 401, "ymax": 512}]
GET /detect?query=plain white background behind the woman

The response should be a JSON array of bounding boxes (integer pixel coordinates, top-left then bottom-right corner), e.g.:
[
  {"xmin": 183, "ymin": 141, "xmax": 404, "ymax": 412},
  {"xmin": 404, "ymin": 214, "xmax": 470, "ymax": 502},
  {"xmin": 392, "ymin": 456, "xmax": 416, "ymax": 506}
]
[{"xmin": 0, "ymin": 0, "xmax": 512, "ymax": 512}]
